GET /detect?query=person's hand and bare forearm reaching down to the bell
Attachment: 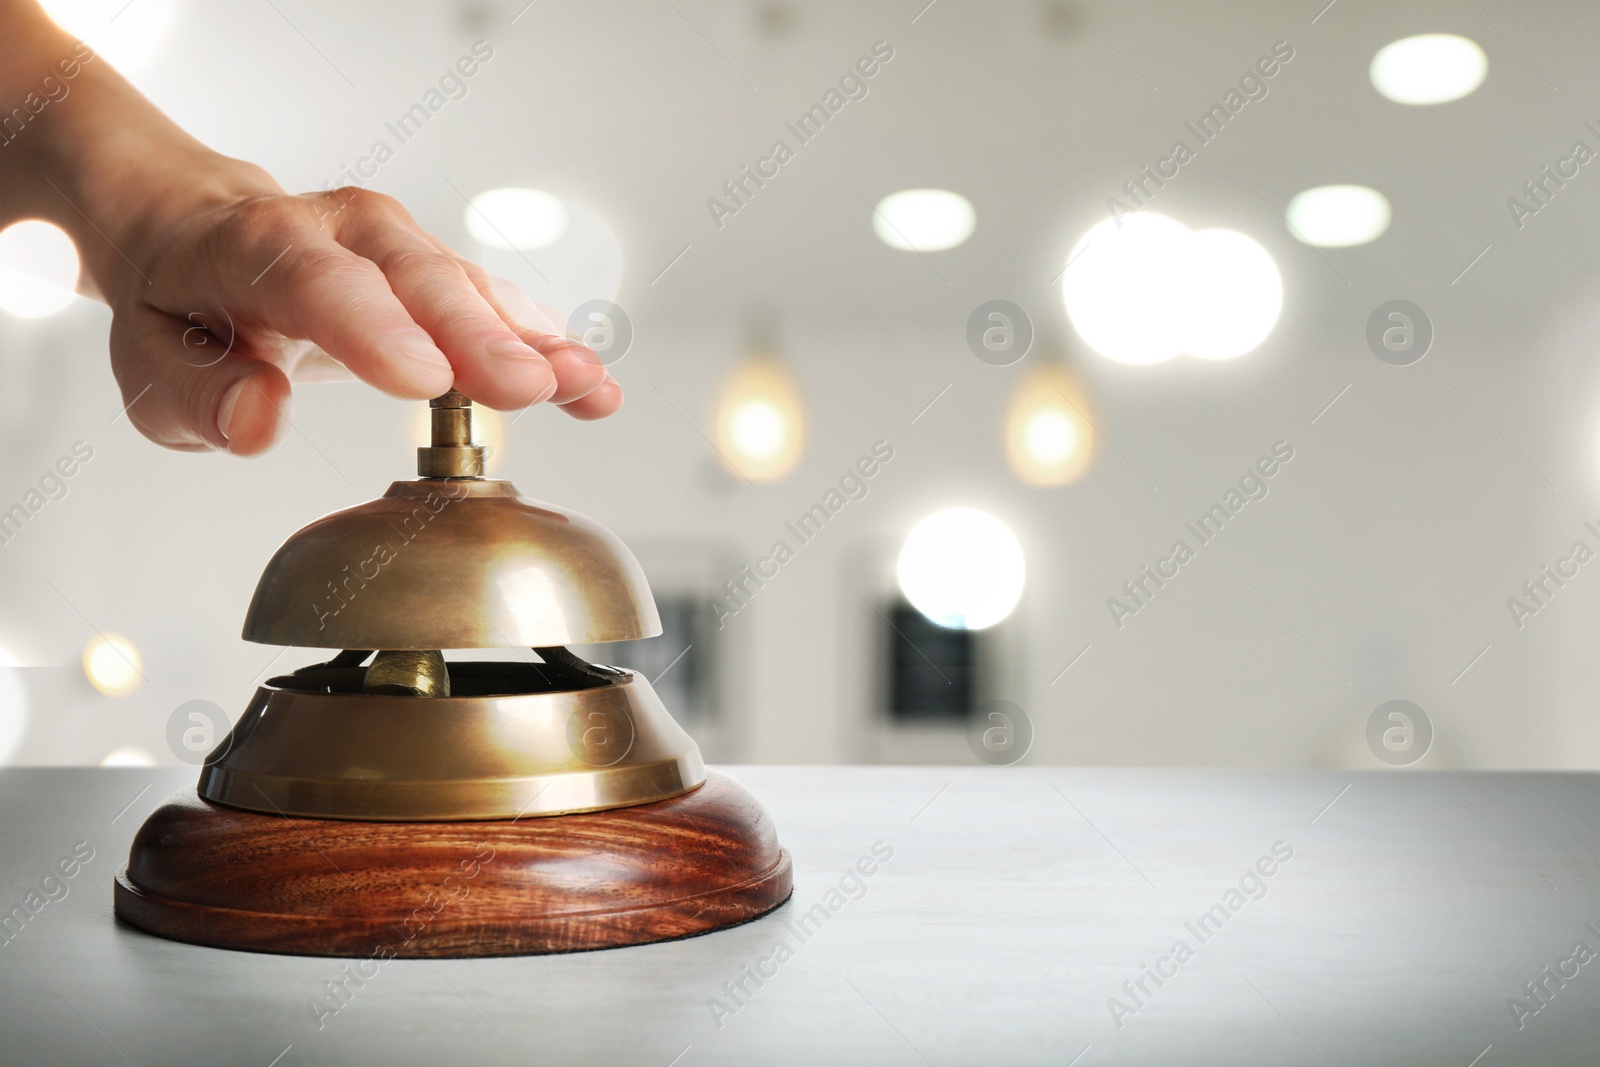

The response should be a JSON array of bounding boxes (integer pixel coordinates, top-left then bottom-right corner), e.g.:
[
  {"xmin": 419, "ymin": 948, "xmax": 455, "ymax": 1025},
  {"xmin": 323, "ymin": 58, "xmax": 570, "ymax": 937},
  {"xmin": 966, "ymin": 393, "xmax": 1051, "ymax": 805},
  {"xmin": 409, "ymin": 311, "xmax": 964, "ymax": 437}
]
[{"xmin": 0, "ymin": 0, "xmax": 622, "ymax": 456}]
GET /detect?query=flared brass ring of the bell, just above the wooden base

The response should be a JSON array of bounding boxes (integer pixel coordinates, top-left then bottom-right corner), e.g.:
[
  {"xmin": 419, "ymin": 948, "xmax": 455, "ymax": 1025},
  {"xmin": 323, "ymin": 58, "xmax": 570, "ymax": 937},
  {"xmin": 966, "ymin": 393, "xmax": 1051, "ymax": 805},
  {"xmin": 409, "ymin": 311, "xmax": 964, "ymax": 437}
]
[{"xmin": 198, "ymin": 664, "xmax": 706, "ymax": 822}]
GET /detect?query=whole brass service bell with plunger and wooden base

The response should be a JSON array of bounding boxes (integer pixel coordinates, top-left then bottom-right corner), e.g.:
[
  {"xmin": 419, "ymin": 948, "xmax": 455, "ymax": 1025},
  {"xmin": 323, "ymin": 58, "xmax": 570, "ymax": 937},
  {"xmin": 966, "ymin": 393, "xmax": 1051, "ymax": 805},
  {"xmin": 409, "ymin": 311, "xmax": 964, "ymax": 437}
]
[{"xmin": 117, "ymin": 392, "xmax": 792, "ymax": 955}]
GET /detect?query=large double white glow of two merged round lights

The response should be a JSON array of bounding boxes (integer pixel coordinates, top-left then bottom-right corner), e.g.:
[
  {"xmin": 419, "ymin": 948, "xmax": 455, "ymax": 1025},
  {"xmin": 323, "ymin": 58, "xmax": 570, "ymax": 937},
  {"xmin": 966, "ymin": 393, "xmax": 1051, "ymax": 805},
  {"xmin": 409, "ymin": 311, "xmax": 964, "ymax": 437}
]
[{"xmin": 1061, "ymin": 211, "xmax": 1283, "ymax": 363}]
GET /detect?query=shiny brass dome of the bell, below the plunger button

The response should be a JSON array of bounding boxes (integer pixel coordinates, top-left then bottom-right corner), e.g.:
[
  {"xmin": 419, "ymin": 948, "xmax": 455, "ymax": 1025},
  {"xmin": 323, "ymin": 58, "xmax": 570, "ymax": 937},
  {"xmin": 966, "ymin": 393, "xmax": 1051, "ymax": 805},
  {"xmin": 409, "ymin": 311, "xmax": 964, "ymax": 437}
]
[{"xmin": 243, "ymin": 478, "xmax": 661, "ymax": 649}]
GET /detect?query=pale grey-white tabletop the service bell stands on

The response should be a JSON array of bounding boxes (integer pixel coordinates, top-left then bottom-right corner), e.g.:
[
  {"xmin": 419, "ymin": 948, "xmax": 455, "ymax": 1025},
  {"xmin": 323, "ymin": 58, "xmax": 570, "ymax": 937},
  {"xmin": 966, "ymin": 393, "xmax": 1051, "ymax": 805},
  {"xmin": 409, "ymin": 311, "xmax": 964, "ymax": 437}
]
[{"xmin": 0, "ymin": 766, "xmax": 1600, "ymax": 1067}]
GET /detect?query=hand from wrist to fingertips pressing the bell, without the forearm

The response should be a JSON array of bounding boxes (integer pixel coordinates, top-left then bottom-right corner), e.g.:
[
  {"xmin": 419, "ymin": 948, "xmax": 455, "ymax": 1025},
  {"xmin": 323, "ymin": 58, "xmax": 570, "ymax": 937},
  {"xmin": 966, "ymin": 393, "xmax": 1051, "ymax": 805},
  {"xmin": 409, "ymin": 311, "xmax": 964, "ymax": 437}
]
[{"xmin": 107, "ymin": 180, "xmax": 622, "ymax": 456}]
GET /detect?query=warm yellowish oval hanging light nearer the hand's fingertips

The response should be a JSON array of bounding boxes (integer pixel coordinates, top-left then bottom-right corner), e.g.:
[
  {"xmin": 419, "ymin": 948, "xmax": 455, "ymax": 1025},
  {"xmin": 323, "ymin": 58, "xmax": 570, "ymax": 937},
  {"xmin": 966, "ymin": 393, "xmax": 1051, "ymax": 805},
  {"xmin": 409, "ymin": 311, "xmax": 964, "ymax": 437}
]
[{"xmin": 717, "ymin": 357, "xmax": 805, "ymax": 482}]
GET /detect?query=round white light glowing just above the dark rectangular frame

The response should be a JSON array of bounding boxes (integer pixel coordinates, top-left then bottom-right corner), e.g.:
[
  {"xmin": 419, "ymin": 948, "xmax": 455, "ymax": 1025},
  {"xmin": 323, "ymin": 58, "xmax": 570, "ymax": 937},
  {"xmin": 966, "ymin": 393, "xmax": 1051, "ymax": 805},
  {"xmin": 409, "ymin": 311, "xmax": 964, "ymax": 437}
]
[{"xmin": 896, "ymin": 507, "xmax": 1027, "ymax": 630}]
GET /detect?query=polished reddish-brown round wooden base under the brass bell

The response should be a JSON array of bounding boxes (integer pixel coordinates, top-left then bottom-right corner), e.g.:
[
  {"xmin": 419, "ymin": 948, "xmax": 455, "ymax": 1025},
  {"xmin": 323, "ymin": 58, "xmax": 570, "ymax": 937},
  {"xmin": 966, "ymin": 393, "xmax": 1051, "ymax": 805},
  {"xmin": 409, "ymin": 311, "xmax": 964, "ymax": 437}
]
[{"xmin": 115, "ymin": 773, "xmax": 792, "ymax": 958}]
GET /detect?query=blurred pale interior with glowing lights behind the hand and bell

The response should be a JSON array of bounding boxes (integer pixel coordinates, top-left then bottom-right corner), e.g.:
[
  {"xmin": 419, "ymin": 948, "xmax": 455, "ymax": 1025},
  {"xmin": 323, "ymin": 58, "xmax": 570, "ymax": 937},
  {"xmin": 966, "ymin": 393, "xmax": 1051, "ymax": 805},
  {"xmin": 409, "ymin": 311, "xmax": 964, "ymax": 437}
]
[{"xmin": 0, "ymin": 0, "xmax": 1600, "ymax": 768}]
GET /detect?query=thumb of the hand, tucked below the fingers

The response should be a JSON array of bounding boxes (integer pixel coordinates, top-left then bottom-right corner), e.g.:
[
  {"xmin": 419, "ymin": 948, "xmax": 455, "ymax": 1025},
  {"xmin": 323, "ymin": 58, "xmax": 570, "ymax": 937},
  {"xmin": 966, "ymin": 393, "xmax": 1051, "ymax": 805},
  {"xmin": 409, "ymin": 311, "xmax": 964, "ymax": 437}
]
[{"xmin": 110, "ymin": 306, "xmax": 290, "ymax": 456}]
